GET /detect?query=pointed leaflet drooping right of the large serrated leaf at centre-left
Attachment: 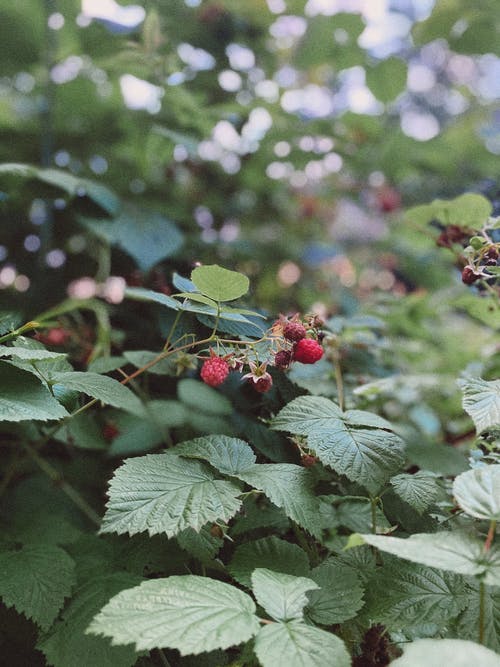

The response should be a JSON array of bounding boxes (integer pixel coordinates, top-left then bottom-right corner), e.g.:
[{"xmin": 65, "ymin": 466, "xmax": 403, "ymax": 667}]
[{"xmin": 237, "ymin": 463, "xmax": 321, "ymax": 537}]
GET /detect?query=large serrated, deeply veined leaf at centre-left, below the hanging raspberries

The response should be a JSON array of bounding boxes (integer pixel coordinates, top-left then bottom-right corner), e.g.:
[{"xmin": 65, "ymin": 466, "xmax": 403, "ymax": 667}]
[{"xmin": 101, "ymin": 454, "xmax": 241, "ymax": 537}]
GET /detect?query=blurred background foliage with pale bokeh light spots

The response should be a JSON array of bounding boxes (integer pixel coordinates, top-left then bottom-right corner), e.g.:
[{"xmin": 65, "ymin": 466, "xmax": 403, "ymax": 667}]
[{"xmin": 0, "ymin": 0, "xmax": 500, "ymax": 317}]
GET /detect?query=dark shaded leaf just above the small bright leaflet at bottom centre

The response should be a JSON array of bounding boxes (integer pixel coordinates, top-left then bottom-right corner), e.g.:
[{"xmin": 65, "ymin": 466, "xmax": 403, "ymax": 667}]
[{"xmin": 228, "ymin": 535, "xmax": 309, "ymax": 588}]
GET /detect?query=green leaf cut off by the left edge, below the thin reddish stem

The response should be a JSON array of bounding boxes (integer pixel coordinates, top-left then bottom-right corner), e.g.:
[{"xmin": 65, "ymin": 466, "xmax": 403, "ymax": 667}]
[{"xmin": 0, "ymin": 361, "xmax": 68, "ymax": 422}]
